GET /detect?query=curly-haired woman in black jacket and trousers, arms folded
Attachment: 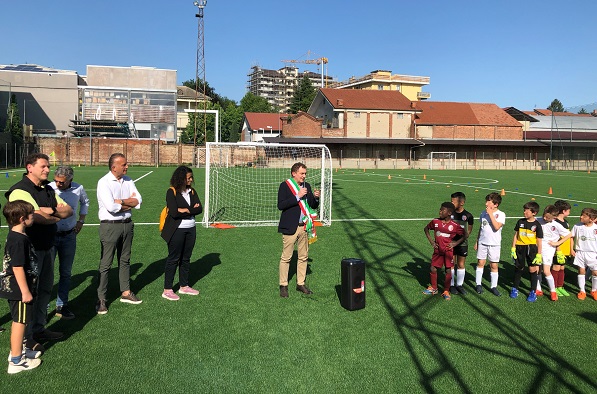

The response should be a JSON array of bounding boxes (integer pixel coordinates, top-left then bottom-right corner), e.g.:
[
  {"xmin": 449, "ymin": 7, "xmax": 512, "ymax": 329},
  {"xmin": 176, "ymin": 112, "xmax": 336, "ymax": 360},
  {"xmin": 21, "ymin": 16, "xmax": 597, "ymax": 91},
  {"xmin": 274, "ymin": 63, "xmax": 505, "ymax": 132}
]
[{"xmin": 162, "ymin": 166, "xmax": 203, "ymax": 301}]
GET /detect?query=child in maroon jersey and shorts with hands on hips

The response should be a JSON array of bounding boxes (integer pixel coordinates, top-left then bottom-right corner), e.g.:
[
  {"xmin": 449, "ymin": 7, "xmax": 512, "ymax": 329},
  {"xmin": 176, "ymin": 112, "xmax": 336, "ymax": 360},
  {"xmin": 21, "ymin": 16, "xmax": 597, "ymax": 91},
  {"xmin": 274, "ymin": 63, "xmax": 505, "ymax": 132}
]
[{"xmin": 423, "ymin": 202, "xmax": 468, "ymax": 300}]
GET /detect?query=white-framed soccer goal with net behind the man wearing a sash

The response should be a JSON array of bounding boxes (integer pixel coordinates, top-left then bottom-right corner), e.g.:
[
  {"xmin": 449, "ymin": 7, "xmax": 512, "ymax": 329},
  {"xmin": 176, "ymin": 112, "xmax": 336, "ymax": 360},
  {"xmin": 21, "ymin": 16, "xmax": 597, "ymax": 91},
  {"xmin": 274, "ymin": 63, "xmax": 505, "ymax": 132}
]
[{"xmin": 203, "ymin": 142, "xmax": 332, "ymax": 227}]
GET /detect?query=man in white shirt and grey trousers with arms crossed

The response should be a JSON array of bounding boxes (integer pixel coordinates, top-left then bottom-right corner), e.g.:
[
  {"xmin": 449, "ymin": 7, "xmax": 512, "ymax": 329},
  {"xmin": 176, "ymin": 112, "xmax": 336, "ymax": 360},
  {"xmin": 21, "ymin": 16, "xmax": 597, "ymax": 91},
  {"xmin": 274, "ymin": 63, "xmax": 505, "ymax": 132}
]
[{"xmin": 96, "ymin": 153, "xmax": 142, "ymax": 315}]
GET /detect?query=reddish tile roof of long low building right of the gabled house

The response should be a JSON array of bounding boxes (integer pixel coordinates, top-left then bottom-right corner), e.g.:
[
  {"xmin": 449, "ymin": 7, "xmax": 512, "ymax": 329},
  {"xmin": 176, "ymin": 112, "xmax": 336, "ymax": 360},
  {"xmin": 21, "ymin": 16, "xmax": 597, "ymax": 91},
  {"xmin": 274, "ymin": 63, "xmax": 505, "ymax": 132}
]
[{"xmin": 416, "ymin": 101, "xmax": 520, "ymax": 127}]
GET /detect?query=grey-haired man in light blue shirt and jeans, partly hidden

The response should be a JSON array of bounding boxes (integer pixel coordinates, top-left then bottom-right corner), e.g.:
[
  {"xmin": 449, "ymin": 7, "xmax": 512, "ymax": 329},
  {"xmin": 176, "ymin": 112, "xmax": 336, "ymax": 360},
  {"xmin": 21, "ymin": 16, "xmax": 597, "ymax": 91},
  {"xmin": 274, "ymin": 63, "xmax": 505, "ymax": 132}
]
[{"xmin": 50, "ymin": 166, "xmax": 89, "ymax": 320}]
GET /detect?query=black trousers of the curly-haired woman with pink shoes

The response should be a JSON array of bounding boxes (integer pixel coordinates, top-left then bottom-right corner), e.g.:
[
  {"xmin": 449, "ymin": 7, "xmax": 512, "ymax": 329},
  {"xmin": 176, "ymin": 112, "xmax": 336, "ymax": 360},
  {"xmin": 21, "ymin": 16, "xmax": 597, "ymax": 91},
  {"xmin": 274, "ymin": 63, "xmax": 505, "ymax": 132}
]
[{"xmin": 164, "ymin": 227, "xmax": 197, "ymax": 289}]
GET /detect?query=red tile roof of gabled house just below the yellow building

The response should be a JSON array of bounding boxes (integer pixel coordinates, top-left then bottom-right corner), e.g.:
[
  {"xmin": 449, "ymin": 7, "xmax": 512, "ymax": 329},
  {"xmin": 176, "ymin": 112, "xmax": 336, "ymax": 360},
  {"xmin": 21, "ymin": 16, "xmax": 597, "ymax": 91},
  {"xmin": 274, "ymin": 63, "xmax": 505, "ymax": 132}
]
[{"xmin": 320, "ymin": 89, "xmax": 413, "ymax": 111}]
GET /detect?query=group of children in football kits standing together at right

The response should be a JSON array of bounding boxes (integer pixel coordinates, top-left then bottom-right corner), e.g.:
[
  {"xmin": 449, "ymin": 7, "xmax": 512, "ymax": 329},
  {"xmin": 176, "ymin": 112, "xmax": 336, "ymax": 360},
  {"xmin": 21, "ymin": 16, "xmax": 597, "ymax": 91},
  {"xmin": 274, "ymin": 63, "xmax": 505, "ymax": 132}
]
[{"xmin": 423, "ymin": 192, "xmax": 597, "ymax": 302}]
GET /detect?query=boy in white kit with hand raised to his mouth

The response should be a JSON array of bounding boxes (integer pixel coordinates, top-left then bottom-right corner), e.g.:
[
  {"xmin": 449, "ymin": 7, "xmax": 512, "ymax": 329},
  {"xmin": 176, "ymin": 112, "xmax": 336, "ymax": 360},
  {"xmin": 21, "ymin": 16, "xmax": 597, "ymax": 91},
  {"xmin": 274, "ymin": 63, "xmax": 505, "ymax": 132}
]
[{"xmin": 475, "ymin": 193, "xmax": 506, "ymax": 296}]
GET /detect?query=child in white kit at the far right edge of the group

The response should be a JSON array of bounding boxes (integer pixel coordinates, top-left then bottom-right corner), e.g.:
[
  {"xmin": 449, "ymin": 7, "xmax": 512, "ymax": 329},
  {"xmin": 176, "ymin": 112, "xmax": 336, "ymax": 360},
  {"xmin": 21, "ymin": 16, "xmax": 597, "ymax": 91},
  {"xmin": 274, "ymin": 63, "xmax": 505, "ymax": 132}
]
[{"xmin": 572, "ymin": 208, "xmax": 597, "ymax": 300}]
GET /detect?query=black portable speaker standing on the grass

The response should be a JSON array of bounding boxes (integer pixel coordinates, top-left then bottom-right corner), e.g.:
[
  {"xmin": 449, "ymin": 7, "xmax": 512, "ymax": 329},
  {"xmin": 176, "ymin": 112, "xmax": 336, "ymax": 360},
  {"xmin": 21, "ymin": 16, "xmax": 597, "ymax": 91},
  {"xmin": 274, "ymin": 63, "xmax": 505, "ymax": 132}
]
[{"xmin": 340, "ymin": 258, "xmax": 365, "ymax": 311}]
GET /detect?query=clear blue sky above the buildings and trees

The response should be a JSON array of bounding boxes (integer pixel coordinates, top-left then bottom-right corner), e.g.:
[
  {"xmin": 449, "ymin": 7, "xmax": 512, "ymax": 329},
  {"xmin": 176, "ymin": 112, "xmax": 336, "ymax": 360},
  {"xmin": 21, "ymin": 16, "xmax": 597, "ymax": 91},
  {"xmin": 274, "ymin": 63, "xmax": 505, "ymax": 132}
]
[{"xmin": 0, "ymin": 0, "xmax": 597, "ymax": 110}]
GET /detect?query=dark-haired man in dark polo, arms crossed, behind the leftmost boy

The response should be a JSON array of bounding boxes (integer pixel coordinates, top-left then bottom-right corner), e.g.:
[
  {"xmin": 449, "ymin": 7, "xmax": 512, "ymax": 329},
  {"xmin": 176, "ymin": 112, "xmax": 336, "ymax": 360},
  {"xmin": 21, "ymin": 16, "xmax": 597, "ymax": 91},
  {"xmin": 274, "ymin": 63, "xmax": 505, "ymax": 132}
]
[{"xmin": 5, "ymin": 153, "xmax": 73, "ymax": 354}]
